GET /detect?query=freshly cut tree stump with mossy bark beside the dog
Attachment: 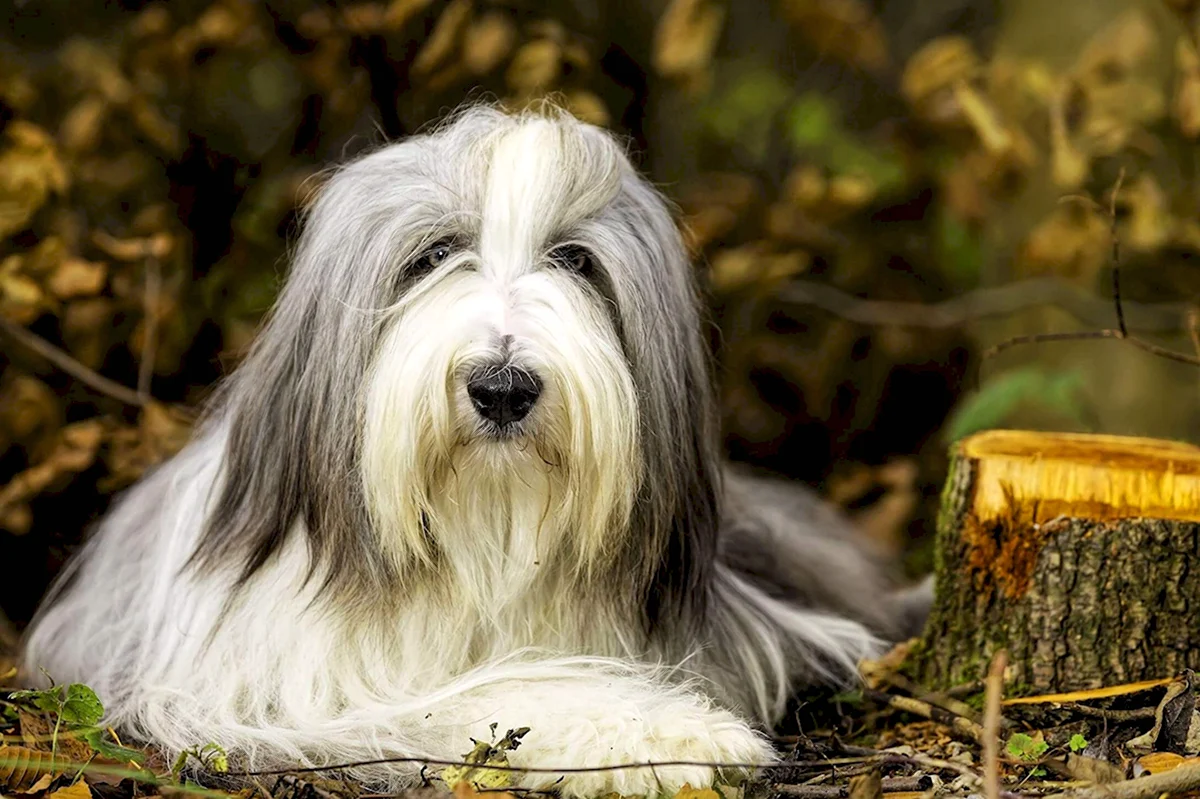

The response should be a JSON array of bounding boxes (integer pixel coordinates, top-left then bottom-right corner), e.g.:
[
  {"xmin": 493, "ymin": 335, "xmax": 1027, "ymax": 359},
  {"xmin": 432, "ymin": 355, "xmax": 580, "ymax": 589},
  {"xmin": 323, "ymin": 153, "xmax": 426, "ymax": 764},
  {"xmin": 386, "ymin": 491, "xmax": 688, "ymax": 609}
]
[{"xmin": 912, "ymin": 431, "xmax": 1200, "ymax": 696}]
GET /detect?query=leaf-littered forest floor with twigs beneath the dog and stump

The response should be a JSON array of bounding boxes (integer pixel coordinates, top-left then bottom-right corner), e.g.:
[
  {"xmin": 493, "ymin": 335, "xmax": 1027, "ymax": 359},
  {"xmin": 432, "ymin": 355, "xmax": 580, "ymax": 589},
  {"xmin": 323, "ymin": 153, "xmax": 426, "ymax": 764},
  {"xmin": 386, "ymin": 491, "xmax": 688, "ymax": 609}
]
[{"xmin": 0, "ymin": 637, "xmax": 1200, "ymax": 799}]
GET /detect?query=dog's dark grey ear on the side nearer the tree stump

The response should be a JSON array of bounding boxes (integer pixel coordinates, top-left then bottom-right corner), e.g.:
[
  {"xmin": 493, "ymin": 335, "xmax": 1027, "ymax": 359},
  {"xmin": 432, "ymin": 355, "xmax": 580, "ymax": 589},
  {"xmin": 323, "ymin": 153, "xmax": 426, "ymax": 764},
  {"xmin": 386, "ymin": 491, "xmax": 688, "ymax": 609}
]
[{"xmin": 613, "ymin": 172, "xmax": 721, "ymax": 627}]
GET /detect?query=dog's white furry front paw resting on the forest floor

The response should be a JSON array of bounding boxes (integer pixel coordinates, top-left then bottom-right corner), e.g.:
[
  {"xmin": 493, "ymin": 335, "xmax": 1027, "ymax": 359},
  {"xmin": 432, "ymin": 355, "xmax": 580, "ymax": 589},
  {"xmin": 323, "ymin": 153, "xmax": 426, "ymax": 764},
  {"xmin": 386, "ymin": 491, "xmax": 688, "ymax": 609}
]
[{"xmin": 511, "ymin": 702, "xmax": 778, "ymax": 799}]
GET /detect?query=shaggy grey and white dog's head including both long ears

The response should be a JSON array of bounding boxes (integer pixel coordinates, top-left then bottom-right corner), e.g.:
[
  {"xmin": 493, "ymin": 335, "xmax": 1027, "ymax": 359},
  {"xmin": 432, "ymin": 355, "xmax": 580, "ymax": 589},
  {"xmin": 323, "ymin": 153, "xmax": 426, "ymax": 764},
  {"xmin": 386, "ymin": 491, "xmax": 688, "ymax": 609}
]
[{"xmin": 199, "ymin": 108, "xmax": 716, "ymax": 615}]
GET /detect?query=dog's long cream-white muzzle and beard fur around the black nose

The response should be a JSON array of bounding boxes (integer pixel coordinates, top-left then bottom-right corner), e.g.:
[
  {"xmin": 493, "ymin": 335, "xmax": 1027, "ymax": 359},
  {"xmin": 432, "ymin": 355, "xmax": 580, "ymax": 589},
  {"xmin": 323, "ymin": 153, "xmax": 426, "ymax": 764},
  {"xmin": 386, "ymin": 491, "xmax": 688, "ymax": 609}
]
[{"xmin": 362, "ymin": 259, "xmax": 642, "ymax": 606}]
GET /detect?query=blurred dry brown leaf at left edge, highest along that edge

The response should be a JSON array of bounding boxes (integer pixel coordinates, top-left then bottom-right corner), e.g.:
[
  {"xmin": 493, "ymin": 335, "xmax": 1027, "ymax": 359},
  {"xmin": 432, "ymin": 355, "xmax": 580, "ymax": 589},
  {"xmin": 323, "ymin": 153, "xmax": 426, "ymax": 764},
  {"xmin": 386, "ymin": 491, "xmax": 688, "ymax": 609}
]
[{"xmin": 0, "ymin": 120, "xmax": 70, "ymax": 239}]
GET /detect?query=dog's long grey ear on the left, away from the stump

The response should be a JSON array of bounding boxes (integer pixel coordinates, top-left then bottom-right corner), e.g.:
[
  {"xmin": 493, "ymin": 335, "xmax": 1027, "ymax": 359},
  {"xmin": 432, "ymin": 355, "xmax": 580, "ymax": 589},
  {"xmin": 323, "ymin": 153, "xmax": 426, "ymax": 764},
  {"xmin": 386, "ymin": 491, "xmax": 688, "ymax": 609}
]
[{"xmin": 190, "ymin": 166, "xmax": 389, "ymax": 584}]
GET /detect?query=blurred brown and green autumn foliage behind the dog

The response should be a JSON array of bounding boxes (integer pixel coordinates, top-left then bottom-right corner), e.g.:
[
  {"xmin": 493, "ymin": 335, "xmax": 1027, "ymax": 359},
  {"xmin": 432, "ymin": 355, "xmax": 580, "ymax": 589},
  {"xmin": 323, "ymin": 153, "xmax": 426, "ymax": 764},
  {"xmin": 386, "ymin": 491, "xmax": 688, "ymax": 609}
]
[{"xmin": 0, "ymin": 0, "xmax": 1200, "ymax": 627}]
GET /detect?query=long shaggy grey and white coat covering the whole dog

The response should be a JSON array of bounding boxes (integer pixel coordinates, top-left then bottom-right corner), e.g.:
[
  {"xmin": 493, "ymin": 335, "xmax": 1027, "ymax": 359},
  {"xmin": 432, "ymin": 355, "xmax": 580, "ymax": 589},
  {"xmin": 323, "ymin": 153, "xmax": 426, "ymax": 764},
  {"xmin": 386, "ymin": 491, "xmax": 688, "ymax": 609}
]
[{"xmin": 24, "ymin": 108, "xmax": 926, "ymax": 795}]
